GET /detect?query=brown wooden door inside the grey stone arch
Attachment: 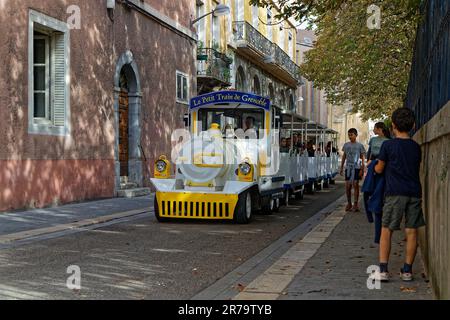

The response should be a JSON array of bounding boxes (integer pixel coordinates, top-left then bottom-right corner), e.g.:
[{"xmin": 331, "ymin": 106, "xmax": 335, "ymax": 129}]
[{"xmin": 119, "ymin": 91, "xmax": 129, "ymax": 177}]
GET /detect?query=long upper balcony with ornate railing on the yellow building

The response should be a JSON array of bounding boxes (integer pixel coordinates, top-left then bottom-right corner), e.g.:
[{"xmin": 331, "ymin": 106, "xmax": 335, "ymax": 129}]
[{"xmin": 233, "ymin": 21, "xmax": 302, "ymax": 87}]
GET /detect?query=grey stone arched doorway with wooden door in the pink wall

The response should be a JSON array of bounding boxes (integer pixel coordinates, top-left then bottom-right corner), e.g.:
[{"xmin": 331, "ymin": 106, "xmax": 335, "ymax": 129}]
[{"xmin": 114, "ymin": 51, "xmax": 143, "ymax": 191}]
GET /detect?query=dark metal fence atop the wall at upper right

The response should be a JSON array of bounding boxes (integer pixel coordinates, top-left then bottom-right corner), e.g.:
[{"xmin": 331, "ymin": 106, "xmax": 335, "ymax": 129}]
[{"xmin": 406, "ymin": 0, "xmax": 450, "ymax": 130}]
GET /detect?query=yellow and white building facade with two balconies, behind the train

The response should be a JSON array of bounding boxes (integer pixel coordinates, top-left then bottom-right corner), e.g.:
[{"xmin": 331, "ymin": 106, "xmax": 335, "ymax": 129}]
[{"xmin": 195, "ymin": 0, "xmax": 301, "ymax": 110}]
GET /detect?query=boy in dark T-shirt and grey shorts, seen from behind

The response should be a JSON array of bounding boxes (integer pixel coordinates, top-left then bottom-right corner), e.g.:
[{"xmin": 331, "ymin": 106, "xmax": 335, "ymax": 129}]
[{"xmin": 375, "ymin": 108, "xmax": 425, "ymax": 281}]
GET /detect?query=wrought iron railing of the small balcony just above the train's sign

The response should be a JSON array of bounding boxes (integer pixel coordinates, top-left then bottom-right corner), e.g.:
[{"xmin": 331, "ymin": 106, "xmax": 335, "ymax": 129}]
[{"xmin": 197, "ymin": 48, "xmax": 233, "ymax": 83}]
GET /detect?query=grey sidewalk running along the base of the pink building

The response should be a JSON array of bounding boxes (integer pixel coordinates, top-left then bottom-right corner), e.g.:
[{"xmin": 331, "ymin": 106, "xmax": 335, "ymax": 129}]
[{"xmin": 0, "ymin": 196, "xmax": 153, "ymax": 240}]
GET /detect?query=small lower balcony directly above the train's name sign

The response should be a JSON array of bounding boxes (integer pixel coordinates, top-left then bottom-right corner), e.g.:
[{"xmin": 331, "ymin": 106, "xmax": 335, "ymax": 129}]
[{"xmin": 197, "ymin": 48, "xmax": 233, "ymax": 94}]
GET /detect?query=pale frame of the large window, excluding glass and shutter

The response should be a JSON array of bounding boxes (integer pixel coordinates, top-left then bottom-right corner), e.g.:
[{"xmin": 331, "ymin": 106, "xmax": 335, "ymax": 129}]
[{"xmin": 28, "ymin": 9, "xmax": 71, "ymax": 136}]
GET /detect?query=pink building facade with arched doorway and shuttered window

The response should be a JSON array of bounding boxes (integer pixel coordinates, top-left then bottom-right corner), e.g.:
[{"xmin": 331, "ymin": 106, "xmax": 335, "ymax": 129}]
[{"xmin": 0, "ymin": 0, "xmax": 196, "ymax": 211}]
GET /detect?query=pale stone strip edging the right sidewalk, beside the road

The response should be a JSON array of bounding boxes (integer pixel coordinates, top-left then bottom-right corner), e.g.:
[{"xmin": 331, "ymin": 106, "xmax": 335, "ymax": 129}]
[{"xmin": 233, "ymin": 204, "xmax": 346, "ymax": 300}]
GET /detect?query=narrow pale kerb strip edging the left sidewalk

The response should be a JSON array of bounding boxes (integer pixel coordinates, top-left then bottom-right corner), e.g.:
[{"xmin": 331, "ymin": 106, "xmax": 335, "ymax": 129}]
[{"xmin": 0, "ymin": 209, "xmax": 152, "ymax": 244}]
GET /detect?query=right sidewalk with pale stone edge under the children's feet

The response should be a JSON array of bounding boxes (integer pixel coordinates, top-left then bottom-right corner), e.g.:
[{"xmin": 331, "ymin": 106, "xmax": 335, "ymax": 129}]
[{"xmin": 233, "ymin": 200, "xmax": 433, "ymax": 300}]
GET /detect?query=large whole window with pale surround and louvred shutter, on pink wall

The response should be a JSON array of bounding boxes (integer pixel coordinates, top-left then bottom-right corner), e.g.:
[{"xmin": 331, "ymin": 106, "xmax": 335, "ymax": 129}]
[{"xmin": 29, "ymin": 10, "xmax": 70, "ymax": 135}]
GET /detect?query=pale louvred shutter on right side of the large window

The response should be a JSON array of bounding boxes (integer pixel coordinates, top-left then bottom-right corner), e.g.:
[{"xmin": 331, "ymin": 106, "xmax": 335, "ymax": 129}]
[{"xmin": 52, "ymin": 34, "xmax": 66, "ymax": 126}]
